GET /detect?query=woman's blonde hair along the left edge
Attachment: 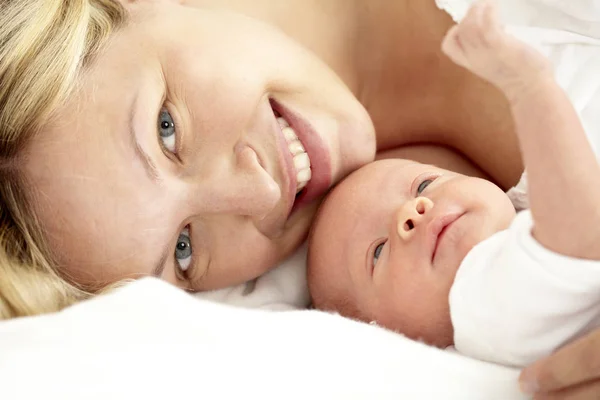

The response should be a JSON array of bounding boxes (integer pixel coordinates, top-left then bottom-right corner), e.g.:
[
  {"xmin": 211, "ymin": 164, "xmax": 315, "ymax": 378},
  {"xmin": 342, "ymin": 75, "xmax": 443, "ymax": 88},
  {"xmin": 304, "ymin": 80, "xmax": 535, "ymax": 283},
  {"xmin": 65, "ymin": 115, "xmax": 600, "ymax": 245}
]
[{"xmin": 0, "ymin": 0, "xmax": 126, "ymax": 319}]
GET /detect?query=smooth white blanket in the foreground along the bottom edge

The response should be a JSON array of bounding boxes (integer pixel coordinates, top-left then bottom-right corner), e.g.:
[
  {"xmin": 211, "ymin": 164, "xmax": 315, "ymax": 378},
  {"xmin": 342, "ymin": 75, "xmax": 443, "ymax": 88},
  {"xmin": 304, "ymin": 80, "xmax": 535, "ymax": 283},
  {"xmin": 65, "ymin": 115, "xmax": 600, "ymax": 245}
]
[{"xmin": 0, "ymin": 278, "xmax": 522, "ymax": 400}]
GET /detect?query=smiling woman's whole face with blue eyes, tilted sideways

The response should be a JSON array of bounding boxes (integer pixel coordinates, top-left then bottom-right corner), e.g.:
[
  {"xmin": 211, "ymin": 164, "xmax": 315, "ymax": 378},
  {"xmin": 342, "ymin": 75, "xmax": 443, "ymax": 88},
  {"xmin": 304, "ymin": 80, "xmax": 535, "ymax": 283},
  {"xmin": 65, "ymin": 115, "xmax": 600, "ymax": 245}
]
[{"xmin": 27, "ymin": 1, "xmax": 375, "ymax": 290}]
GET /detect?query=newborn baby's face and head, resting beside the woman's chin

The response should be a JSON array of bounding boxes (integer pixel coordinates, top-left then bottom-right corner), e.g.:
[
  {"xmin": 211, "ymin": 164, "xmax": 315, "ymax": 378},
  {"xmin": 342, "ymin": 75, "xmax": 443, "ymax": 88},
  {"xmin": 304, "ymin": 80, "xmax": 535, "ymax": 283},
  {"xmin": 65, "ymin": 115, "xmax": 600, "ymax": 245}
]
[{"xmin": 310, "ymin": 159, "xmax": 515, "ymax": 346}]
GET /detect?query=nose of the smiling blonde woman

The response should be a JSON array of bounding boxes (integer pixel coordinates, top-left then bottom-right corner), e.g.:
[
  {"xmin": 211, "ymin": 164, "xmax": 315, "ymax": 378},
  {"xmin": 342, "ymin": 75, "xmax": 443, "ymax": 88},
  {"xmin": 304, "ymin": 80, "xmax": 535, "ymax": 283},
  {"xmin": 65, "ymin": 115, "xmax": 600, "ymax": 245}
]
[{"xmin": 191, "ymin": 147, "xmax": 281, "ymax": 219}]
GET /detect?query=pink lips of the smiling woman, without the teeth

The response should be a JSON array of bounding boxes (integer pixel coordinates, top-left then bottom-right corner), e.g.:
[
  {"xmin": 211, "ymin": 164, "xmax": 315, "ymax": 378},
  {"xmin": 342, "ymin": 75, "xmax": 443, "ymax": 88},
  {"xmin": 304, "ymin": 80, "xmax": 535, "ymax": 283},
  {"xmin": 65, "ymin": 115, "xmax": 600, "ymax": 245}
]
[{"xmin": 270, "ymin": 99, "xmax": 332, "ymax": 216}]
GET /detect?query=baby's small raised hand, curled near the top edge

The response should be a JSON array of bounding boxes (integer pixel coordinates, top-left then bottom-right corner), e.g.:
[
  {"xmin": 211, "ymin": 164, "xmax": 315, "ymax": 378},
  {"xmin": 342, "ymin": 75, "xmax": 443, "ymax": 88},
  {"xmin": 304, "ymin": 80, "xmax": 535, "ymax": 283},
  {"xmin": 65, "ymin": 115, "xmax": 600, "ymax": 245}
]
[{"xmin": 442, "ymin": 0, "xmax": 551, "ymax": 98}]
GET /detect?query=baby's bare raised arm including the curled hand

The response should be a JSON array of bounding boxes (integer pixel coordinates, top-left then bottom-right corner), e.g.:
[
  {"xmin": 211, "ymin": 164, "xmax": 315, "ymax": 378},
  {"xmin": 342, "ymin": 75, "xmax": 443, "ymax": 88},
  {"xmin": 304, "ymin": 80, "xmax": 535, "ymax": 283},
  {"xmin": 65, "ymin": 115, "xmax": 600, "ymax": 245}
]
[{"xmin": 443, "ymin": 1, "xmax": 600, "ymax": 260}]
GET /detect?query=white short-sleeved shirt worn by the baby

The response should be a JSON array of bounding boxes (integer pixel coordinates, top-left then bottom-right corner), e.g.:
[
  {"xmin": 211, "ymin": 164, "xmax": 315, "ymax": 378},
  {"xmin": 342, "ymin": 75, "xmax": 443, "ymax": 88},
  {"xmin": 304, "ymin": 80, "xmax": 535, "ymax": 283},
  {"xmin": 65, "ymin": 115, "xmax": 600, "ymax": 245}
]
[{"xmin": 449, "ymin": 211, "xmax": 600, "ymax": 366}]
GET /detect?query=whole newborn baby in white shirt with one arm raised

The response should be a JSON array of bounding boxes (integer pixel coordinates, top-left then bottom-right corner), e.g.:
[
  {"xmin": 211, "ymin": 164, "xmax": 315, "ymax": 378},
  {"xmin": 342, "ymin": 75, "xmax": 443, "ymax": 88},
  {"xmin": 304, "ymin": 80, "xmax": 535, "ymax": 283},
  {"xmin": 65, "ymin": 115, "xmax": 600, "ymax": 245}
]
[{"xmin": 308, "ymin": 2, "xmax": 600, "ymax": 366}]
